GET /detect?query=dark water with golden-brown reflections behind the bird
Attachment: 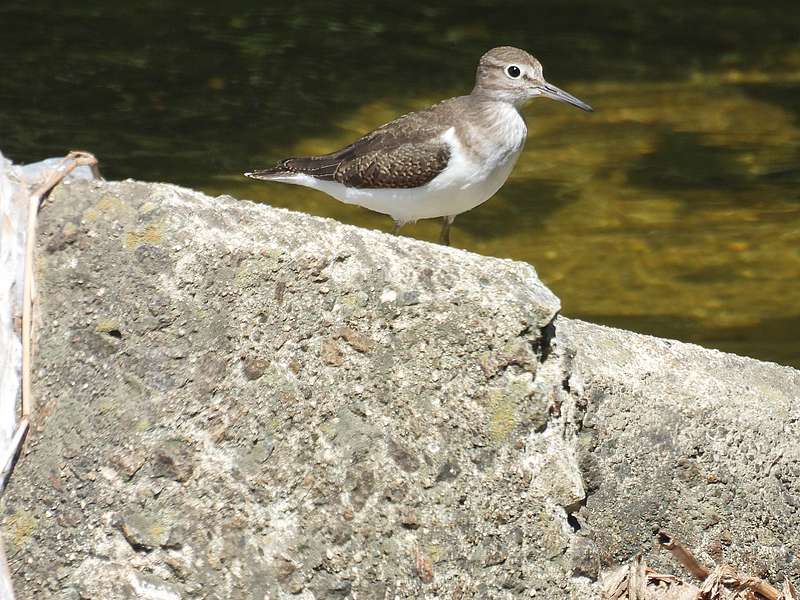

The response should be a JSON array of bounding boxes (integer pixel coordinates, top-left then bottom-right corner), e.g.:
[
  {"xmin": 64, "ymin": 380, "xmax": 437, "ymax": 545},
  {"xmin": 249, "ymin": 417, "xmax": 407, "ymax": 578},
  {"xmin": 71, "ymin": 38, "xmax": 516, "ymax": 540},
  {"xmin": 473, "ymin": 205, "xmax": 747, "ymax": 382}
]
[{"xmin": 0, "ymin": 0, "xmax": 800, "ymax": 366}]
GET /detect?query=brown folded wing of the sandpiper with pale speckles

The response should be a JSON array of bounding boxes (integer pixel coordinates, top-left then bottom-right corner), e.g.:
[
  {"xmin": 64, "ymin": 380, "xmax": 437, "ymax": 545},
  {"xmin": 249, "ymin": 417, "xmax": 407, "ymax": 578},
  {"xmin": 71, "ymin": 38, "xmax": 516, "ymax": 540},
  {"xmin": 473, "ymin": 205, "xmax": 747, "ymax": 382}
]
[{"xmin": 251, "ymin": 105, "xmax": 450, "ymax": 189}]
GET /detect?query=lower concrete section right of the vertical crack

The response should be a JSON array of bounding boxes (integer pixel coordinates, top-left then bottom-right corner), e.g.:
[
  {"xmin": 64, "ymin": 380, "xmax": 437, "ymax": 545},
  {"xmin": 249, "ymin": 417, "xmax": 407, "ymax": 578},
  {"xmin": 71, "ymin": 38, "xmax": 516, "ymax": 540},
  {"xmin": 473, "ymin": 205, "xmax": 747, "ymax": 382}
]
[{"xmin": 556, "ymin": 318, "xmax": 800, "ymax": 582}]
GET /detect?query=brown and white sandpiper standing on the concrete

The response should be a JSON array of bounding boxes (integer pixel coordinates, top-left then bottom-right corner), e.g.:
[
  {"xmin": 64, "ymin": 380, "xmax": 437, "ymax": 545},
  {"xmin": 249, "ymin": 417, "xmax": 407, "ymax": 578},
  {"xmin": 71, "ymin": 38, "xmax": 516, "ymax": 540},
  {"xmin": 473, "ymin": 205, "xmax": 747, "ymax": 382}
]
[{"xmin": 245, "ymin": 46, "xmax": 592, "ymax": 245}]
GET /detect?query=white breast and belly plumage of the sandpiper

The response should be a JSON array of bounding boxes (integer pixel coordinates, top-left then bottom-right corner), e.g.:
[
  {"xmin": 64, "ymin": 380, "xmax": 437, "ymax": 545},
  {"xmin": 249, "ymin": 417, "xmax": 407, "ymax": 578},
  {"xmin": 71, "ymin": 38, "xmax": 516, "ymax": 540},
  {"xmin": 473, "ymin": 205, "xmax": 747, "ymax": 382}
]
[{"xmin": 272, "ymin": 102, "xmax": 527, "ymax": 223}]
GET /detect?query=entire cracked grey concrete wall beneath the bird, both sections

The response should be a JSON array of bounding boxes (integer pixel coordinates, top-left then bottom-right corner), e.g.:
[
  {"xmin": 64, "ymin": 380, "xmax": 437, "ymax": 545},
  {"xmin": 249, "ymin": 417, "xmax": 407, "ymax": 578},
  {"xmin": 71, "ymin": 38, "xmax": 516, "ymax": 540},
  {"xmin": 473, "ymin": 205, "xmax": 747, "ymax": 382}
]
[{"xmin": 3, "ymin": 182, "xmax": 800, "ymax": 599}]
